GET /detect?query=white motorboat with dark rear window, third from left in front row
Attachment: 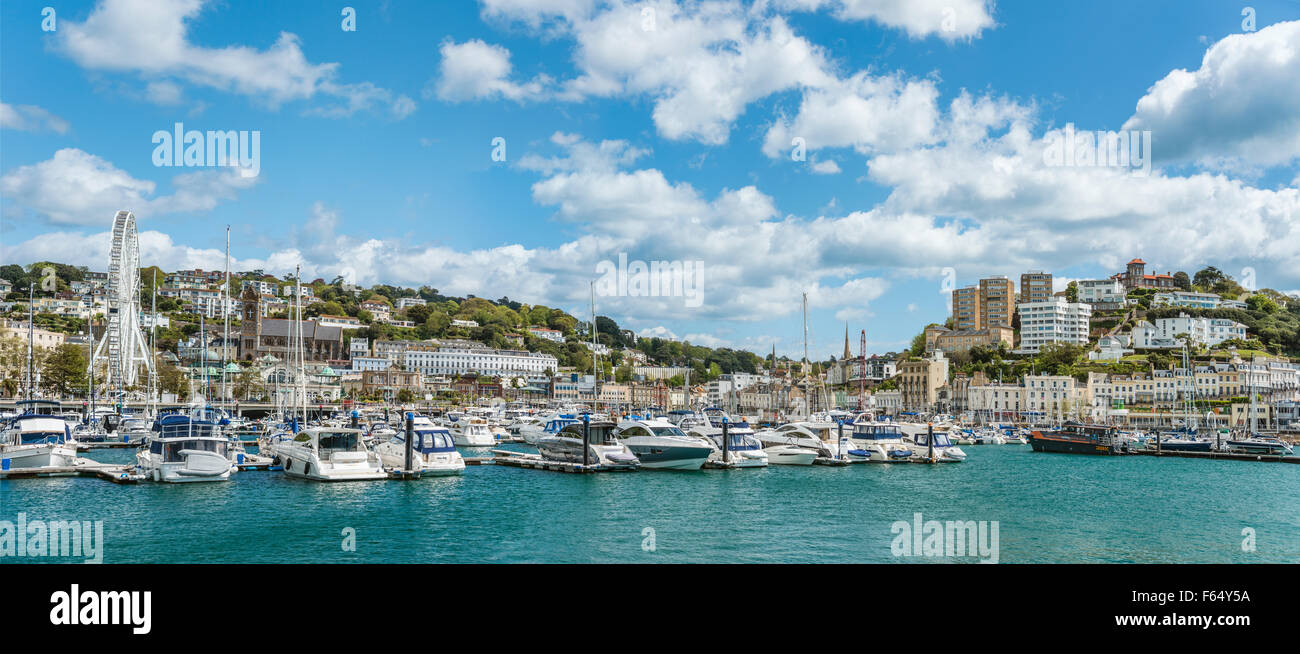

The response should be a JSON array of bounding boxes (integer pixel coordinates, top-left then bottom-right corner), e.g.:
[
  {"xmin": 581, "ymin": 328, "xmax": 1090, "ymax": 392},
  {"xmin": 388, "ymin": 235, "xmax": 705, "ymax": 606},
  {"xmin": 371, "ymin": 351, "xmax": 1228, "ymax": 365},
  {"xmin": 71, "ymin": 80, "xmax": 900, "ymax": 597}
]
[{"xmin": 276, "ymin": 428, "xmax": 389, "ymax": 481}]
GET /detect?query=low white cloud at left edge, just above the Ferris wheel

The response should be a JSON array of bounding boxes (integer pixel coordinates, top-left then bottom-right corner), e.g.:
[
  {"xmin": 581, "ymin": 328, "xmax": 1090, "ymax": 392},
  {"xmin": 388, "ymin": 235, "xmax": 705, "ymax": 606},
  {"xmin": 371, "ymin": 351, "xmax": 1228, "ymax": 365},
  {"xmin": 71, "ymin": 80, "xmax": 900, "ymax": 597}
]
[{"xmin": 0, "ymin": 148, "xmax": 257, "ymax": 225}]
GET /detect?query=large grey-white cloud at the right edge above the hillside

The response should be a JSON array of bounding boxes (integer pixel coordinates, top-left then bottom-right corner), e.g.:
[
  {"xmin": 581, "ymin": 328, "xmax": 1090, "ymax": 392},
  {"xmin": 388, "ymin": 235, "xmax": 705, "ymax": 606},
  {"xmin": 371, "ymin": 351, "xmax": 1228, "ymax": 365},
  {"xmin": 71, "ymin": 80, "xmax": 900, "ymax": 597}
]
[{"xmin": 1125, "ymin": 21, "xmax": 1300, "ymax": 169}]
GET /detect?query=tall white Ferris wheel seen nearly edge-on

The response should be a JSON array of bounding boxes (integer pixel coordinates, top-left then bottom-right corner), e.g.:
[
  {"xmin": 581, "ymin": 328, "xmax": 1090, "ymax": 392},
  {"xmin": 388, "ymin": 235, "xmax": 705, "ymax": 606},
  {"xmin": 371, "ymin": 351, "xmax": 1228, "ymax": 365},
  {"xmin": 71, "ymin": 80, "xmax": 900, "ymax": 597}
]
[{"xmin": 90, "ymin": 211, "xmax": 153, "ymax": 389}]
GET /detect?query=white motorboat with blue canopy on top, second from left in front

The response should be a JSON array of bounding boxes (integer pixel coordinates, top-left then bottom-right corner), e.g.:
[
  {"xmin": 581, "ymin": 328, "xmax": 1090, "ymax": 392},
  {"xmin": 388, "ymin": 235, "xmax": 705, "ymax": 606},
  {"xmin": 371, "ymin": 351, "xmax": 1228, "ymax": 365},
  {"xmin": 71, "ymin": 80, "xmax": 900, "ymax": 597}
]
[{"xmin": 135, "ymin": 413, "xmax": 239, "ymax": 484}]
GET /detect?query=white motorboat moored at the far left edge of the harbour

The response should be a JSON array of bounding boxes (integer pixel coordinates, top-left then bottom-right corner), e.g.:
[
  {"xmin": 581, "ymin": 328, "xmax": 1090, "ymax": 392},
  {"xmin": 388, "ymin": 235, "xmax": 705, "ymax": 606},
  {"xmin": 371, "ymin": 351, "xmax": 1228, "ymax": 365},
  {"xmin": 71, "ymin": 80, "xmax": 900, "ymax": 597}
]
[{"xmin": 0, "ymin": 399, "xmax": 77, "ymax": 469}]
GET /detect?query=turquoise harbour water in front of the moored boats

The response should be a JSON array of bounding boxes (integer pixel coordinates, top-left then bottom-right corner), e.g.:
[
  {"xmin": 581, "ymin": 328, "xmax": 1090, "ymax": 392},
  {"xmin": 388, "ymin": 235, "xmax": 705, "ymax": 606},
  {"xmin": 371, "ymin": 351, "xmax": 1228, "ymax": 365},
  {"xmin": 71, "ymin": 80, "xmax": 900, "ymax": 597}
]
[{"xmin": 0, "ymin": 445, "xmax": 1300, "ymax": 563}]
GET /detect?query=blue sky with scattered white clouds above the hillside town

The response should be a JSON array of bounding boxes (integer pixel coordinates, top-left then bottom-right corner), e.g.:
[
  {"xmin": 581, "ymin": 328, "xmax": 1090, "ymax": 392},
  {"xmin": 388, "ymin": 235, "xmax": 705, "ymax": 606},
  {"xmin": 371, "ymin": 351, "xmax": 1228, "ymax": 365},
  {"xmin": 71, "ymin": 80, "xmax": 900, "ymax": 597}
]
[{"xmin": 0, "ymin": 0, "xmax": 1300, "ymax": 355}]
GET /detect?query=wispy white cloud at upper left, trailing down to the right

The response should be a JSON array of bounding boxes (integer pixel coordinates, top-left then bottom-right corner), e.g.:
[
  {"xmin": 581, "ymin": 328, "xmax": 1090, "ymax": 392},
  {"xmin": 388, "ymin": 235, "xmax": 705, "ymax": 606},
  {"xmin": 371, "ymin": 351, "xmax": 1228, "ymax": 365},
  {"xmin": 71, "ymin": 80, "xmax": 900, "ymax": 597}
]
[{"xmin": 55, "ymin": 0, "xmax": 411, "ymax": 116}]
